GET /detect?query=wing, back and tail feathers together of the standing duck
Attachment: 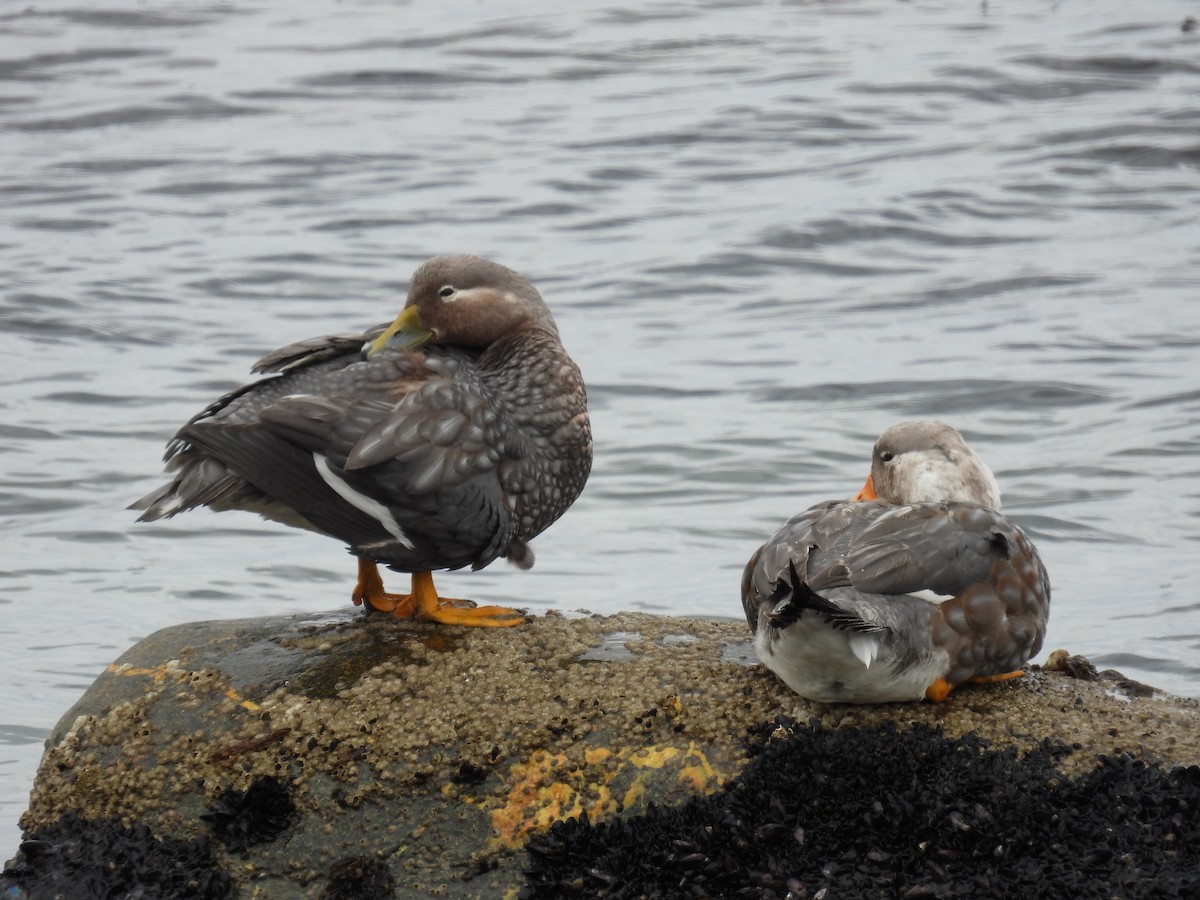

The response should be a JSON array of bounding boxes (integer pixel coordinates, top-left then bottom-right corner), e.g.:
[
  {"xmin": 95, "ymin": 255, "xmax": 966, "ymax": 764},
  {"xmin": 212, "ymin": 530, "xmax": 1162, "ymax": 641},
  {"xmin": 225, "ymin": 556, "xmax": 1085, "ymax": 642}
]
[{"xmin": 133, "ymin": 330, "xmax": 523, "ymax": 569}]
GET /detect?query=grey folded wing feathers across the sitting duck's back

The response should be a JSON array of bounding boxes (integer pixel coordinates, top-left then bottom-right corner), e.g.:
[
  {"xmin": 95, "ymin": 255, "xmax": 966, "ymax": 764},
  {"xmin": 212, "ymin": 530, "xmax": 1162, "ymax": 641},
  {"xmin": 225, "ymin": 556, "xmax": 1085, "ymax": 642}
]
[{"xmin": 840, "ymin": 503, "xmax": 1015, "ymax": 596}]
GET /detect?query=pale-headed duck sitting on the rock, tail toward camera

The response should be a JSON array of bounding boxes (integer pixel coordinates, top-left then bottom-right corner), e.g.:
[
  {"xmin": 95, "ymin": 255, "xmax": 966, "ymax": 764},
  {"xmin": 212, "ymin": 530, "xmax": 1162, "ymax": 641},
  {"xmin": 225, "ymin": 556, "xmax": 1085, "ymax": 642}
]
[{"xmin": 742, "ymin": 421, "xmax": 1050, "ymax": 703}]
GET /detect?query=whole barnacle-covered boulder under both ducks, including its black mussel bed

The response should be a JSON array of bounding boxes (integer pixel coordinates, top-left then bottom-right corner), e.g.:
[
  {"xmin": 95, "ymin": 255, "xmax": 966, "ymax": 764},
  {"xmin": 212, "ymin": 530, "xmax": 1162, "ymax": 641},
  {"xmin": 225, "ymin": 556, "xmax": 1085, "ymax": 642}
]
[{"xmin": 0, "ymin": 611, "xmax": 1200, "ymax": 900}]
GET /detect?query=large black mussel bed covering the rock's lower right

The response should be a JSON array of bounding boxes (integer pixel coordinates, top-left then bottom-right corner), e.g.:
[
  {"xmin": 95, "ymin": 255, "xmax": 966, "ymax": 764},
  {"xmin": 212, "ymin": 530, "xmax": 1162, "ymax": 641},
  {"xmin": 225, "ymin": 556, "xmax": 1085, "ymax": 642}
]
[{"xmin": 520, "ymin": 719, "xmax": 1200, "ymax": 900}]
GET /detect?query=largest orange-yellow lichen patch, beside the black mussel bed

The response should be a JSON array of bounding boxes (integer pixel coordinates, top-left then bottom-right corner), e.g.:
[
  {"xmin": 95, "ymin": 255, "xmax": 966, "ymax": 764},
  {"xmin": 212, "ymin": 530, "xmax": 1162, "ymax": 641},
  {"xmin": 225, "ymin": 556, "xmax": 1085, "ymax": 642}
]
[{"xmin": 480, "ymin": 743, "xmax": 725, "ymax": 847}]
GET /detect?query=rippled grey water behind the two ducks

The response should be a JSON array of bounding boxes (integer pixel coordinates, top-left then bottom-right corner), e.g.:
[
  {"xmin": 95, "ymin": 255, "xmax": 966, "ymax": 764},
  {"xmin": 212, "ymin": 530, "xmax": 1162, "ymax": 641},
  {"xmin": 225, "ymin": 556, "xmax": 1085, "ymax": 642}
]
[{"xmin": 0, "ymin": 0, "xmax": 1200, "ymax": 851}]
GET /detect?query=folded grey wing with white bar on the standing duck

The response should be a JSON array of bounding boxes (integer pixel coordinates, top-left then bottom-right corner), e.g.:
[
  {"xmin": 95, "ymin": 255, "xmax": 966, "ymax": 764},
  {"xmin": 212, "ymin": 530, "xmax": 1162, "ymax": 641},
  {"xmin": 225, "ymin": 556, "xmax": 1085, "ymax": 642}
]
[{"xmin": 180, "ymin": 349, "xmax": 521, "ymax": 569}]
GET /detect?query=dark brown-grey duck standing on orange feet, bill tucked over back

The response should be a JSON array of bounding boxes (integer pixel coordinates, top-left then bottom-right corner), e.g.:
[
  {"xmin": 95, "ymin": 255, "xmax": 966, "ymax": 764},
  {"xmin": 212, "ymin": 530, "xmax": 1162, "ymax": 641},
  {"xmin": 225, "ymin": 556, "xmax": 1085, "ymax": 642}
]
[{"xmin": 131, "ymin": 256, "xmax": 592, "ymax": 626}]
